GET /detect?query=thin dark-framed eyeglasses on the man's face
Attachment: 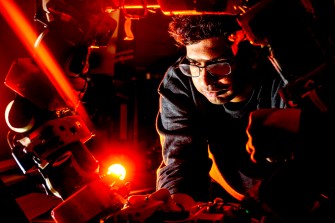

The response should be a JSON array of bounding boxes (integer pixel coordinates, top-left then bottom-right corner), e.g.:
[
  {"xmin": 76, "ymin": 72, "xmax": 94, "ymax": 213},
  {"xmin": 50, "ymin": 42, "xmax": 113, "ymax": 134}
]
[{"xmin": 176, "ymin": 57, "xmax": 231, "ymax": 78}]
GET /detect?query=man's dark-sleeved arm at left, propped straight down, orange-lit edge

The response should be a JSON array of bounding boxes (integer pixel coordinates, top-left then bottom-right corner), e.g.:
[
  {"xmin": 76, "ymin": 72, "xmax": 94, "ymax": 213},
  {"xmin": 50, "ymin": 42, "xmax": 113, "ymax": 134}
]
[{"xmin": 156, "ymin": 68, "xmax": 211, "ymax": 201}]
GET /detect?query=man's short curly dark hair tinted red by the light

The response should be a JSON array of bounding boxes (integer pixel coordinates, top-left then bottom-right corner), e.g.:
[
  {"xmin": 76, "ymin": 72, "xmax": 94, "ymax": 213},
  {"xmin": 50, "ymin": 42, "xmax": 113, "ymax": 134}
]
[{"xmin": 168, "ymin": 15, "xmax": 241, "ymax": 46}]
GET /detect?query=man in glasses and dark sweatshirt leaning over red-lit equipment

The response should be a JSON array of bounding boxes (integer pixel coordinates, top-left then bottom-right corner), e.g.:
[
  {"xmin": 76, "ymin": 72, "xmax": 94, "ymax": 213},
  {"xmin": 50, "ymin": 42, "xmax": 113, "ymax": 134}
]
[{"xmin": 156, "ymin": 15, "xmax": 285, "ymax": 210}]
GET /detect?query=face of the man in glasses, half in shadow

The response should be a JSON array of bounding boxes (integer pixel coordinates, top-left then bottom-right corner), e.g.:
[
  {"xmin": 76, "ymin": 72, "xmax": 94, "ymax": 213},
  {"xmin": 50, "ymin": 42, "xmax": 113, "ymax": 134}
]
[{"xmin": 186, "ymin": 31, "xmax": 255, "ymax": 104}]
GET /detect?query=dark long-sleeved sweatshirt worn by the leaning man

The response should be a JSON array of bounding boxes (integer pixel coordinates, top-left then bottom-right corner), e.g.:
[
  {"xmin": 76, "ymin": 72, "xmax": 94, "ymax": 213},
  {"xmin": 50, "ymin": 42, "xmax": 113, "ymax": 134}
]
[{"xmin": 156, "ymin": 56, "xmax": 284, "ymax": 201}]
